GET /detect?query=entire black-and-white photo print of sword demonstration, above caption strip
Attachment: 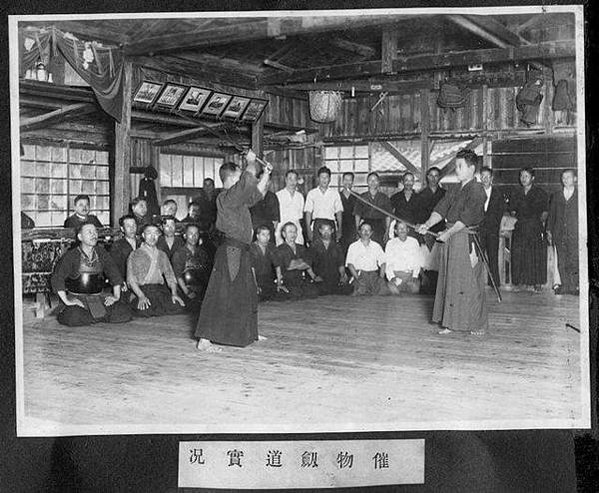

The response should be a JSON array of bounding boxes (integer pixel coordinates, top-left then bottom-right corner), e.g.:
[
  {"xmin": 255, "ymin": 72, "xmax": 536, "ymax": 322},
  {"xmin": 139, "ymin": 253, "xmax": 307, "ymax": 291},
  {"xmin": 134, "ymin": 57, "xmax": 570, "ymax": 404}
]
[{"xmin": 7, "ymin": 5, "xmax": 591, "ymax": 437}]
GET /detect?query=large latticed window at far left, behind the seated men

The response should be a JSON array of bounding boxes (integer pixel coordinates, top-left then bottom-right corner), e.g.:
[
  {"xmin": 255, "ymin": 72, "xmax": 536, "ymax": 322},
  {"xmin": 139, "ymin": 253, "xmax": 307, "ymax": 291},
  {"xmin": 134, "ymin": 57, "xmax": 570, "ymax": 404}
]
[{"xmin": 21, "ymin": 144, "xmax": 110, "ymax": 227}]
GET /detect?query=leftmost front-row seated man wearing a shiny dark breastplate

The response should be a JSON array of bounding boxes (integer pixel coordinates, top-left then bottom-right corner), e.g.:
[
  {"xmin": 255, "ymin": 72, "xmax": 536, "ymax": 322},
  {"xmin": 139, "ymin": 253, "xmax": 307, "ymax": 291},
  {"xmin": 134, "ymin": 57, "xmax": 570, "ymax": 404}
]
[{"xmin": 51, "ymin": 223, "xmax": 131, "ymax": 327}]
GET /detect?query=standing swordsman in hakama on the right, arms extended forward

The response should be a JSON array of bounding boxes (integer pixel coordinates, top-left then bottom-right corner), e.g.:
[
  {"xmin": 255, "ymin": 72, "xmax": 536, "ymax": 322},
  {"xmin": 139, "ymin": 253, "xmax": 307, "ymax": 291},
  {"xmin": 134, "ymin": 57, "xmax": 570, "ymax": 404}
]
[{"xmin": 418, "ymin": 150, "xmax": 489, "ymax": 335}]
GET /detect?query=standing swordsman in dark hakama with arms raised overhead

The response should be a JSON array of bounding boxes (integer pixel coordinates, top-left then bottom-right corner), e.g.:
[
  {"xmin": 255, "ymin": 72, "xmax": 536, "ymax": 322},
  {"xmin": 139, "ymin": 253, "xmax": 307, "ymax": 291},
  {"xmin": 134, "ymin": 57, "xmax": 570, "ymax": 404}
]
[{"xmin": 195, "ymin": 150, "xmax": 272, "ymax": 352}]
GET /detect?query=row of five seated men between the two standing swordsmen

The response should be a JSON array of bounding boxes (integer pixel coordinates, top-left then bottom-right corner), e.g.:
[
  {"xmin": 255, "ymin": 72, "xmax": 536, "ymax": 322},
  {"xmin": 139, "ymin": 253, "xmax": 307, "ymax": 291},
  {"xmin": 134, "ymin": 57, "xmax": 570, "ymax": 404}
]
[{"xmin": 250, "ymin": 217, "xmax": 422, "ymax": 301}]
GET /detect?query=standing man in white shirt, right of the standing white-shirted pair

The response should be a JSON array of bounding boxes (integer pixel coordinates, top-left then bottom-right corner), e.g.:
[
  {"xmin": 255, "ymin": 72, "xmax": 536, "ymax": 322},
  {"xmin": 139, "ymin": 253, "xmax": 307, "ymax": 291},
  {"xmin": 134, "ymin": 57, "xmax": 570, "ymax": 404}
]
[{"xmin": 308, "ymin": 166, "xmax": 343, "ymax": 242}]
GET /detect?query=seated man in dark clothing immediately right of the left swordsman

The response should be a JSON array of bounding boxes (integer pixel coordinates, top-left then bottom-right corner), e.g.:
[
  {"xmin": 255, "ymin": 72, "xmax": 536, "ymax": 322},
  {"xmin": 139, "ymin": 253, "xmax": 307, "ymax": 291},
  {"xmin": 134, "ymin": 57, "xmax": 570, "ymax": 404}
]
[{"xmin": 250, "ymin": 225, "xmax": 287, "ymax": 301}]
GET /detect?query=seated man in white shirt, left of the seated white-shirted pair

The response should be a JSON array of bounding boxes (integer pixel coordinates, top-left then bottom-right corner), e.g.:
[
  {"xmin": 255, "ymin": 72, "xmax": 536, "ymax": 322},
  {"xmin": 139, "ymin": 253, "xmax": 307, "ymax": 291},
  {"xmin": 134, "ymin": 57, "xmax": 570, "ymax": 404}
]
[{"xmin": 345, "ymin": 222, "xmax": 389, "ymax": 296}]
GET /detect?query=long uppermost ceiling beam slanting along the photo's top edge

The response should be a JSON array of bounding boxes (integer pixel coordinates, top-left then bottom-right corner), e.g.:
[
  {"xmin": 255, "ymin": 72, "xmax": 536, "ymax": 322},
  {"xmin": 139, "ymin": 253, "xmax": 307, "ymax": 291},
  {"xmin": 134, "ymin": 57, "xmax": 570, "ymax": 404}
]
[{"xmin": 124, "ymin": 15, "xmax": 409, "ymax": 56}]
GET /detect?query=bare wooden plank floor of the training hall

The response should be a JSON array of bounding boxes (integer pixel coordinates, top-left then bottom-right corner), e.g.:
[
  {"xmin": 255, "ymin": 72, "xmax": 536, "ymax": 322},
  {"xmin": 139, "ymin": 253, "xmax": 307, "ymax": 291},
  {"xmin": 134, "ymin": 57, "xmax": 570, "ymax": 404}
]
[{"xmin": 20, "ymin": 292, "xmax": 582, "ymax": 435}]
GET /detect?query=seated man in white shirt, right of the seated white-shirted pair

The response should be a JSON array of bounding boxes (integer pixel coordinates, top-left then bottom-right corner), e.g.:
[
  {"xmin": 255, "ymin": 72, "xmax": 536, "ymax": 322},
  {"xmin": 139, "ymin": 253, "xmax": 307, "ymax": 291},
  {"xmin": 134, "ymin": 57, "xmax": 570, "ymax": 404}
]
[{"xmin": 385, "ymin": 221, "xmax": 422, "ymax": 294}]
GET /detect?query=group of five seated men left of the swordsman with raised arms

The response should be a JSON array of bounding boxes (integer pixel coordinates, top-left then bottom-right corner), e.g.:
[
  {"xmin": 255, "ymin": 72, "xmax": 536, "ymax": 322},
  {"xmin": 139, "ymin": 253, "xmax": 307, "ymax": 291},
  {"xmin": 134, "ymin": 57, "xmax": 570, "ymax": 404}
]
[{"xmin": 51, "ymin": 209, "xmax": 210, "ymax": 326}]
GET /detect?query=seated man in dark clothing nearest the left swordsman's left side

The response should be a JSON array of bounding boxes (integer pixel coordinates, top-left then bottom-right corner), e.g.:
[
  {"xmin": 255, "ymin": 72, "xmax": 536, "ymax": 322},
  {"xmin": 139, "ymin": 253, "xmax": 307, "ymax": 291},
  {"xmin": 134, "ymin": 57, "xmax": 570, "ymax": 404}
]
[{"xmin": 172, "ymin": 223, "xmax": 211, "ymax": 312}]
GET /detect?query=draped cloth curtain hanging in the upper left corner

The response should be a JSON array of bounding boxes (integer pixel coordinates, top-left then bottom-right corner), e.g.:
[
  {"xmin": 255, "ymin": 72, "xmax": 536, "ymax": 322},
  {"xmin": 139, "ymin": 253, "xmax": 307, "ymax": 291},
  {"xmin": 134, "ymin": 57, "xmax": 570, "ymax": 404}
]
[{"xmin": 19, "ymin": 27, "xmax": 123, "ymax": 122}]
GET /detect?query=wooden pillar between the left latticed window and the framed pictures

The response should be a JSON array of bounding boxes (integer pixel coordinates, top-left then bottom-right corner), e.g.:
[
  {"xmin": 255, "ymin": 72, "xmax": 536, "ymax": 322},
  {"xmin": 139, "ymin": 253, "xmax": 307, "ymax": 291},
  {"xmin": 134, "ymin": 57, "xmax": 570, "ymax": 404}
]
[{"xmin": 110, "ymin": 59, "xmax": 132, "ymax": 226}]
